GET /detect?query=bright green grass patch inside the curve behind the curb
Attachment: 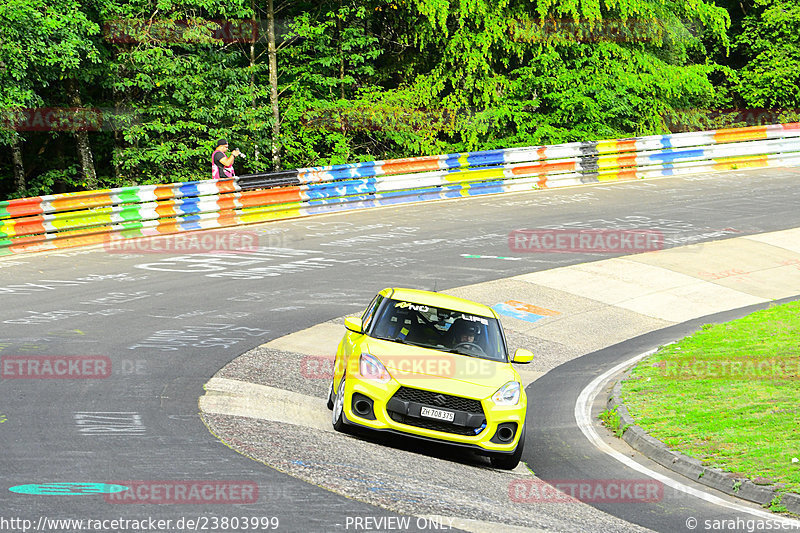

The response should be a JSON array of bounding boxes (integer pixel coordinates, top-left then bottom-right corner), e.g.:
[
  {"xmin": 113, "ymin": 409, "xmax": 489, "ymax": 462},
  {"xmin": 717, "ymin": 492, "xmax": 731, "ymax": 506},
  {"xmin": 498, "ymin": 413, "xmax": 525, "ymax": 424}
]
[{"xmin": 622, "ymin": 301, "xmax": 800, "ymax": 493}]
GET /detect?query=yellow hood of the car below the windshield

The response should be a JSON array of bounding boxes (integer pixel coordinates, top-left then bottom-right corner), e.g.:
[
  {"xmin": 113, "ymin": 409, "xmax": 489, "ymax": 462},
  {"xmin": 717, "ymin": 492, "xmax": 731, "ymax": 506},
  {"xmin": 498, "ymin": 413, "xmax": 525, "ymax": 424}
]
[{"xmin": 362, "ymin": 339, "xmax": 520, "ymax": 398}]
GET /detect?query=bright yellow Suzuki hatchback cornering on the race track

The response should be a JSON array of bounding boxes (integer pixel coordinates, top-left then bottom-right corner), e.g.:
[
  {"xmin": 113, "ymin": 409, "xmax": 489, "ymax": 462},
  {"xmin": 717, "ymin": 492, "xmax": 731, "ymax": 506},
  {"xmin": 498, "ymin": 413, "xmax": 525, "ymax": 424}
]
[{"xmin": 328, "ymin": 288, "xmax": 533, "ymax": 469}]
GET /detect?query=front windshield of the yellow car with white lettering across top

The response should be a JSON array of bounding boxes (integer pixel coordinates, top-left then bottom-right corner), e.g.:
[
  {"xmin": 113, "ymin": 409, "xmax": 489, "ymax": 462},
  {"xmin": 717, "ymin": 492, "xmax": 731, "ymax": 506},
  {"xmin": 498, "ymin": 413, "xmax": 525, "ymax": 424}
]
[{"xmin": 370, "ymin": 298, "xmax": 508, "ymax": 361}]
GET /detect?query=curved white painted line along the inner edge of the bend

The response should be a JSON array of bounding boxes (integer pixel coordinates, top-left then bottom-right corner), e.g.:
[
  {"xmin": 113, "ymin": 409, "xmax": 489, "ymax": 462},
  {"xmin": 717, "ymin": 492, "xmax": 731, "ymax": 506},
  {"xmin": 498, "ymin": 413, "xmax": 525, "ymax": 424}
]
[{"xmin": 575, "ymin": 349, "xmax": 798, "ymax": 528}]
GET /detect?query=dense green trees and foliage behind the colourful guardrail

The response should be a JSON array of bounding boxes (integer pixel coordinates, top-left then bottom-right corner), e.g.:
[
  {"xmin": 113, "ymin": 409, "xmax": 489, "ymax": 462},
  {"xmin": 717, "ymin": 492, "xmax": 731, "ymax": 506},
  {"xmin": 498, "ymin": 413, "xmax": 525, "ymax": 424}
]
[{"xmin": 0, "ymin": 0, "xmax": 800, "ymax": 197}]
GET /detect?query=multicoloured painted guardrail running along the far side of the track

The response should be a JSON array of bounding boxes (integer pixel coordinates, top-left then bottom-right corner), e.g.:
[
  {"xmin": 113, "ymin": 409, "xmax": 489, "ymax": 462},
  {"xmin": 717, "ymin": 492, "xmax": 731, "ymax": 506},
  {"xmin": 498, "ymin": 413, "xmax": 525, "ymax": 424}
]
[{"xmin": 0, "ymin": 123, "xmax": 800, "ymax": 255}]
